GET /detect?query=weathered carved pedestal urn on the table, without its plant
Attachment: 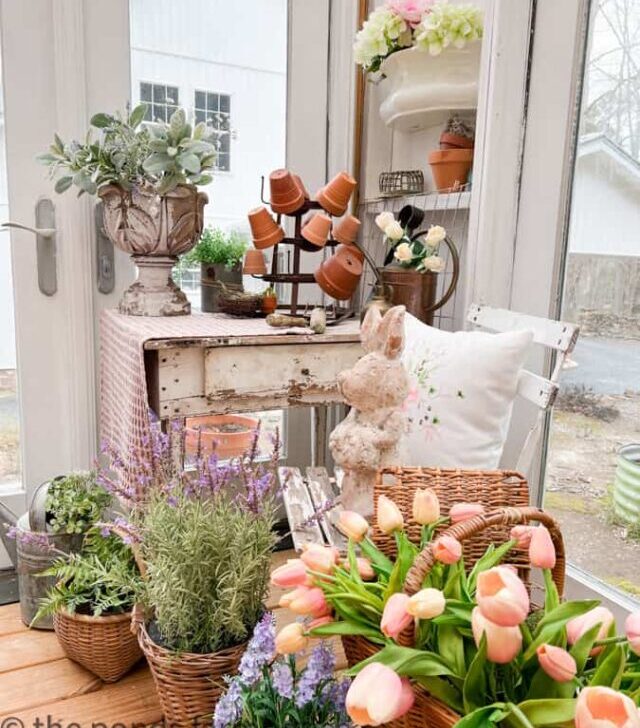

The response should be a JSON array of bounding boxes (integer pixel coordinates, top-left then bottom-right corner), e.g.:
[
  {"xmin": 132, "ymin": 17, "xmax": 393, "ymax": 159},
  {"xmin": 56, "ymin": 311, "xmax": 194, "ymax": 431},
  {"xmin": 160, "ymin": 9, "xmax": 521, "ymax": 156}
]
[{"xmin": 98, "ymin": 184, "xmax": 208, "ymax": 316}]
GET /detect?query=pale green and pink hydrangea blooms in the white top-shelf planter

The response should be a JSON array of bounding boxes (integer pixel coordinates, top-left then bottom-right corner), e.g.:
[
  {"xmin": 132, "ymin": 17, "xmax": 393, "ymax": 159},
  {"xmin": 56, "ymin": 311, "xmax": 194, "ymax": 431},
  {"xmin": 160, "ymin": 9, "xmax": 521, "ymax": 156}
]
[{"xmin": 354, "ymin": 0, "xmax": 483, "ymax": 73}]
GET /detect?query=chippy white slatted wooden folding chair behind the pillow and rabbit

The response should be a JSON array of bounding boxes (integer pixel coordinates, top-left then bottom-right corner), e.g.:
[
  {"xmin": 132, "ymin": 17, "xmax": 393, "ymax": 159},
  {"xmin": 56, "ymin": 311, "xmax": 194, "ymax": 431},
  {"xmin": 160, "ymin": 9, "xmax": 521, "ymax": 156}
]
[{"xmin": 279, "ymin": 304, "xmax": 579, "ymax": 550}]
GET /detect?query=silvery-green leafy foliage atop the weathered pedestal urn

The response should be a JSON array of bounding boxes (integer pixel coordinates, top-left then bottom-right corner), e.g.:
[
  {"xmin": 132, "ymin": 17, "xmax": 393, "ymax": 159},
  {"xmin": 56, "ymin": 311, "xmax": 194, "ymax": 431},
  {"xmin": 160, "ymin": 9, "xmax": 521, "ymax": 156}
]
[{"xmin": 38, "ymin": 104, "xmax": 229, "ymax": 196}]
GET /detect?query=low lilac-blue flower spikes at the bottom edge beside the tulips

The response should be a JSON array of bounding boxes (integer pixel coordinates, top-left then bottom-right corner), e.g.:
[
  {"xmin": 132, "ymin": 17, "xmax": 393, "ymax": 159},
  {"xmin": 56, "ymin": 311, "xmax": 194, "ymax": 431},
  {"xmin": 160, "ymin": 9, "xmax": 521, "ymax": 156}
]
[{"xmin": 218, "ymin": 614, "xmax": 351, "ymax": 728}]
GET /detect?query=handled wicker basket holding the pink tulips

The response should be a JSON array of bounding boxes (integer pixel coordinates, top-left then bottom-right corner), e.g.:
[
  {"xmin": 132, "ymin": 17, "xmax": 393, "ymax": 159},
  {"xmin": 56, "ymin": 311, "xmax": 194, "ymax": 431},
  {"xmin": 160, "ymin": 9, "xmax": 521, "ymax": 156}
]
[{"xmin": 342, "ymin": 468, "xmax": 565, "ymax": 728}]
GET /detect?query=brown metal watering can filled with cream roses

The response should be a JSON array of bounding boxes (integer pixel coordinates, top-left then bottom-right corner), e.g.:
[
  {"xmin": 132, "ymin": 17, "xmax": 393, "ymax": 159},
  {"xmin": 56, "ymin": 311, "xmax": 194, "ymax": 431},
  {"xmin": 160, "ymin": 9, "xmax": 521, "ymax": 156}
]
[{"xmin": 376, "ymin": 212, "xmax": 459, "ymax": 324}]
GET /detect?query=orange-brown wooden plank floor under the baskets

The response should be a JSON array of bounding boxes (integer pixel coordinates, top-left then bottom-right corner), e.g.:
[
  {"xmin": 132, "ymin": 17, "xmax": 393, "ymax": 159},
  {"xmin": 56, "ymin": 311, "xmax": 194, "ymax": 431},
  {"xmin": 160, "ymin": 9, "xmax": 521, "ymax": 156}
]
[{"xmin": 0, "ymin": 552, "xmax": 346, "ymax": 728}]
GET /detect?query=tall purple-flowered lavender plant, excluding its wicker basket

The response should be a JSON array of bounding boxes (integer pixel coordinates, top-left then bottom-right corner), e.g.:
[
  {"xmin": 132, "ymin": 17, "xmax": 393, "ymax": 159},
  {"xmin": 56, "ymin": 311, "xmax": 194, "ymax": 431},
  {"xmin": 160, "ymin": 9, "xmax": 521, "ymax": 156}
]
[{"xmin": 101, "ymin": 420, "xmax": 280, "ymax": 654}]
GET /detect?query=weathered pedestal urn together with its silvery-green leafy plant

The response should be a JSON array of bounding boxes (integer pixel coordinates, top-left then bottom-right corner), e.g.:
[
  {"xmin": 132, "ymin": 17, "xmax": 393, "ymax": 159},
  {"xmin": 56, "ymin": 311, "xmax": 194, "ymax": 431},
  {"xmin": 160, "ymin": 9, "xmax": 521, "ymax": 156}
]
[{"xmin": 40, "ymin": 104, "xmax": 227, "ymax": 316}]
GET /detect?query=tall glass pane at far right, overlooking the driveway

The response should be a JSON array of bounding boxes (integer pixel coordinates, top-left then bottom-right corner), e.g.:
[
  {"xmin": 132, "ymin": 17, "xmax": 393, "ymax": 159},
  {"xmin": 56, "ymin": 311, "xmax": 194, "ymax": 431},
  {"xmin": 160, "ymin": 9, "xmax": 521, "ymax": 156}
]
[{"xmin": 545, "ymin": 0, "xmax": 640, "ymax": 596}]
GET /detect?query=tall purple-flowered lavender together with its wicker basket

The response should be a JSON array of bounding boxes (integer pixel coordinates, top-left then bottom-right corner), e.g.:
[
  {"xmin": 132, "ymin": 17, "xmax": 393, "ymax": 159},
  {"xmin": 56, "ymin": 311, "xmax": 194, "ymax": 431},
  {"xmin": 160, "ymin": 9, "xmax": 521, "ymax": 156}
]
[{"xmin": 103, "ymin": 430, "xmax": 279, "ymax": 725}]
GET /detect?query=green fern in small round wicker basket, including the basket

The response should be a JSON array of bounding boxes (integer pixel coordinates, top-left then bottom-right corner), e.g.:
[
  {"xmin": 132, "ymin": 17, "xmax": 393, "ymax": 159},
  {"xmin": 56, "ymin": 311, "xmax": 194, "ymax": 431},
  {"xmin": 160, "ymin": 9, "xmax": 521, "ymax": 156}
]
[{"xmin": 34, "ymin": 529, "xmax": 142, "ymax": 682}]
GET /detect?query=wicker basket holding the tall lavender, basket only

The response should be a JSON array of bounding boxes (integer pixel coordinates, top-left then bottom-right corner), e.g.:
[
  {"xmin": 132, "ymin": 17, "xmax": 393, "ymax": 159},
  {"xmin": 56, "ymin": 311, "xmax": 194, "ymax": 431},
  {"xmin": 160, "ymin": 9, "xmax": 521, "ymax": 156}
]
[{"xmin": 133, "ymin": 607, "xmax": 246, "ymax": 728}]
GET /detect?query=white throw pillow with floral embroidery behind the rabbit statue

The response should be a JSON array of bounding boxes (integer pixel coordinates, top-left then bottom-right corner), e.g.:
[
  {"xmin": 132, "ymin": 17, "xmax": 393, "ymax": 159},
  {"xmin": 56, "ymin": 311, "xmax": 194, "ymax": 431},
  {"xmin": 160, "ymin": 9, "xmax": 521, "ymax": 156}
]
[{"xmin": 402, "ymin": 314, "xmax": 533, "ymax": 470}]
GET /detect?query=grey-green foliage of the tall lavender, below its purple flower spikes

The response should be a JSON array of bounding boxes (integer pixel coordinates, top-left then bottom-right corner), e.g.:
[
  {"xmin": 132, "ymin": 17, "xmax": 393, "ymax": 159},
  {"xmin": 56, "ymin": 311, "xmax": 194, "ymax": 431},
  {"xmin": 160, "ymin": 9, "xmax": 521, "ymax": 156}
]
[{"xmin": 141, "ymin": 493, "xmax": 276, "ymax": 653}]
